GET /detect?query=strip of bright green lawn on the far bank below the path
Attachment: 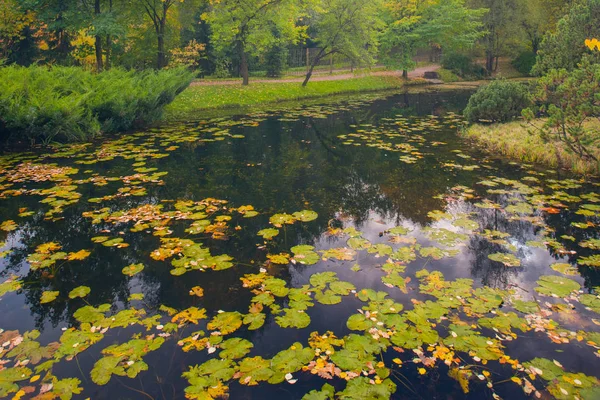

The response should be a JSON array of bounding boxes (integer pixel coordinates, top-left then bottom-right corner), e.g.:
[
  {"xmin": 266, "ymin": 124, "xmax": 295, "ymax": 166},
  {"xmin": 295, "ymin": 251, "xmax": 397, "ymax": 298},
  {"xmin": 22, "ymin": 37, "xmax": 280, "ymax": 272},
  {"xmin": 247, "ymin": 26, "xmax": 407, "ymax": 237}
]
[{"xmin": 166, "ymin": 76, "xmax": 405, "ymax": 118}]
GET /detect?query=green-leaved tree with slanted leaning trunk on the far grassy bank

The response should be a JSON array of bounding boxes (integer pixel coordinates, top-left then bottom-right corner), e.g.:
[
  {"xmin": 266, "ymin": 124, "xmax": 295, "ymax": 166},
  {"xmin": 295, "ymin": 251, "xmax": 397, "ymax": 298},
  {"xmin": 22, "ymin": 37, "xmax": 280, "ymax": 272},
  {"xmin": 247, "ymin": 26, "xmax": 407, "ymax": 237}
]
[{"xmin": 302, "ymin": 0, "xmax": 384, "ymax": 86}]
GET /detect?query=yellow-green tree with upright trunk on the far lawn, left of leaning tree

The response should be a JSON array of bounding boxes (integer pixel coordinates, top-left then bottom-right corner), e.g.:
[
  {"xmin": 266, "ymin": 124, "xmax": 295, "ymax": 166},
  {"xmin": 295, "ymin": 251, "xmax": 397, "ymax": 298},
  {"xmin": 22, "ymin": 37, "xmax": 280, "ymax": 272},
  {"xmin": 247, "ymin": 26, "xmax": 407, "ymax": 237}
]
[{"xmin": 203, "ymin": 0, "xmax": 305, "ymax": 85}]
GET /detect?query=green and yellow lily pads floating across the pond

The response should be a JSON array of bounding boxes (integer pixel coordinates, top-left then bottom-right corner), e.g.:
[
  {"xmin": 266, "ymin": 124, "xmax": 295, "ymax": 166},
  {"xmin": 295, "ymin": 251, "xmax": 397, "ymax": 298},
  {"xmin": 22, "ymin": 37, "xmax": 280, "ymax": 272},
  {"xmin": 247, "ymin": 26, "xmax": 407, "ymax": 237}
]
[{"xmin": 0, "ymin": 94, "xmax": 600, "ymax": 400}]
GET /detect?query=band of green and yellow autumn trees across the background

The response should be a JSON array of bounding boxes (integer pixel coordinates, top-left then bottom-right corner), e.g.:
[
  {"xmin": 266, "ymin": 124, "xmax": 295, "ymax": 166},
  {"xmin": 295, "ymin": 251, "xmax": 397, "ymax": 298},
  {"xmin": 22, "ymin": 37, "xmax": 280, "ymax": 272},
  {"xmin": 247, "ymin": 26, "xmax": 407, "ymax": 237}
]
[{"xmin": 0, "ymin": 0, "xmax": 576, "ymax": 83}]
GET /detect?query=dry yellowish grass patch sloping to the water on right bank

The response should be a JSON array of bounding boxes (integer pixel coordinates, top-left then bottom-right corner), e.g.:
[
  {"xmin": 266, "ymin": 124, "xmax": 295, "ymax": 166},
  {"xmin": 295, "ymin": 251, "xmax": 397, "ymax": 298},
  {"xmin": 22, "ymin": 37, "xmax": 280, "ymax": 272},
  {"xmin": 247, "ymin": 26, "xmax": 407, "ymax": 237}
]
[{"xmin": 462, "ymin": 121, "xmax": 600, "ymax": 174}]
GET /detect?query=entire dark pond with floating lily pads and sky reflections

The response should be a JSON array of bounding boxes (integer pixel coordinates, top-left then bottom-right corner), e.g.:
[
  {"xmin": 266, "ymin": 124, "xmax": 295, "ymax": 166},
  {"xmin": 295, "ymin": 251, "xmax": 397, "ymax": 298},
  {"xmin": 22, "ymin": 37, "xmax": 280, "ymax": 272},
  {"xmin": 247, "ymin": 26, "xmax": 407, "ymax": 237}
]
[{"xmin": 0, "ymin": 91, "xmax": 600, "ymax": 399}]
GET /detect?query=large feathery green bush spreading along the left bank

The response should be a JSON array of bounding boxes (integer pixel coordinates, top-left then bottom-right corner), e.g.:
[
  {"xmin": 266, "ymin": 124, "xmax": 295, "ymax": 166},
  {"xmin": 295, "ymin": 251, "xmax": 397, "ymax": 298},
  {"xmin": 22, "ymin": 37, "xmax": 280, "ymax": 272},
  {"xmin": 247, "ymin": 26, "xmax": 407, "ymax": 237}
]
[{"xmin": 0, "ymin": 66, "xmax": 192, "ymax": 143}]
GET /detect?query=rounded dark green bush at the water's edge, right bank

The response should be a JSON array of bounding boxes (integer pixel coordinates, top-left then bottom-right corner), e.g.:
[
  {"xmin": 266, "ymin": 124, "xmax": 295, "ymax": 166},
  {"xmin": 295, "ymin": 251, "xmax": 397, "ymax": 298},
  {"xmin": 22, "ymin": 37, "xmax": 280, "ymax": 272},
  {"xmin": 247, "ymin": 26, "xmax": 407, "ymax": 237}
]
[{"xmin": 464, "ymin": 80, "xmax": 531, "ymax": 122}]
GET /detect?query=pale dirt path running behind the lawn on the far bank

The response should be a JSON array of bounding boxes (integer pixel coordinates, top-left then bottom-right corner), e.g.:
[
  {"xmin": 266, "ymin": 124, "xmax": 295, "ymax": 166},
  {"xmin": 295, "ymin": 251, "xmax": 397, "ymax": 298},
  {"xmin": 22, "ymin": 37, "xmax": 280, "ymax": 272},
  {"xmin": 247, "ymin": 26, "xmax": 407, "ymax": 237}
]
[{"xmin": 191, "ymin": 65, "xmax": 441, "ymax": 86}]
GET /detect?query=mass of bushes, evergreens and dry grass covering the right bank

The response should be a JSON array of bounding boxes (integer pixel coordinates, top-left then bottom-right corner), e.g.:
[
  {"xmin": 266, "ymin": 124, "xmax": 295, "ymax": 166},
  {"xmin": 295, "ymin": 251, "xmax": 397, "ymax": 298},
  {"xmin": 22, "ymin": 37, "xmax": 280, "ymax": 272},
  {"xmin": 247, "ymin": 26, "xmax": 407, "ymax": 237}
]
[{"xmin": 465, "ymin": 0, "xmax": 600, "ymax": 173}]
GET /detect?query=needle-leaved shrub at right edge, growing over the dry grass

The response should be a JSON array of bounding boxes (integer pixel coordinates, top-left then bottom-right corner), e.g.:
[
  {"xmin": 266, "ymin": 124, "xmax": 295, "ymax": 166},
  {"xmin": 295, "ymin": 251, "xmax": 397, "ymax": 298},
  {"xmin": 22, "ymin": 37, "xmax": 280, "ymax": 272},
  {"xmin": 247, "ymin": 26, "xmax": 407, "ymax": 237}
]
[{"xmin": 524, "ymin": 57, "xmax": 600, "ymax": 162}]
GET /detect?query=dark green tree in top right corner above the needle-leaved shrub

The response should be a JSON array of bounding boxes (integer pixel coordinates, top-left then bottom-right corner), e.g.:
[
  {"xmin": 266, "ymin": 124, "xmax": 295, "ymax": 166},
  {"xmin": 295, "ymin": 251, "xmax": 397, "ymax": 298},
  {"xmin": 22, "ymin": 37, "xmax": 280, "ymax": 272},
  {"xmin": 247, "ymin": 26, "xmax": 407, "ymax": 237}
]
[{"xmin": 533, "ymin": 0, "xmax": 600, "ymax": 75}]
